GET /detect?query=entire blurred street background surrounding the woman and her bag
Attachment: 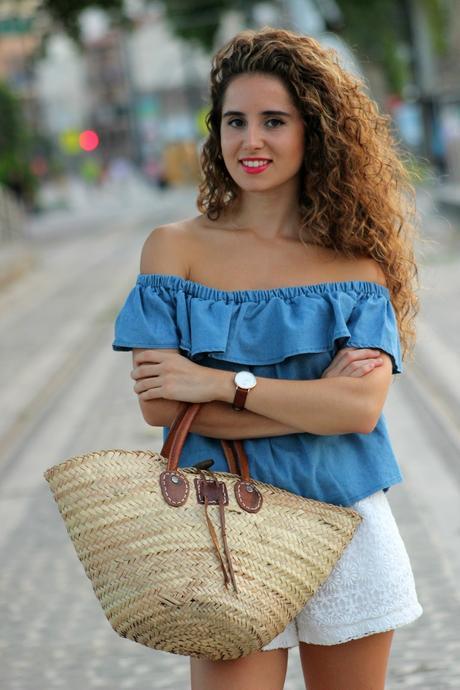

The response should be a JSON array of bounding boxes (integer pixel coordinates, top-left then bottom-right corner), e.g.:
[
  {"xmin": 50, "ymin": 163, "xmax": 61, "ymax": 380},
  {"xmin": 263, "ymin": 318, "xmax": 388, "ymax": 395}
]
[{"xmin": 0, "ymin": 0, "xmax": 460, "ymax": 690}]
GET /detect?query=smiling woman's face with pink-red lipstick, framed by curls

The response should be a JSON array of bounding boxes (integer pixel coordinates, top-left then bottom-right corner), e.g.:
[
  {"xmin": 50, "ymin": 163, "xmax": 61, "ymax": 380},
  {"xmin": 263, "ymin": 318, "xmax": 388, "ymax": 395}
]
[{"xmin": 220, "ymin": 73, "xmax": 304, "ymax": 191}]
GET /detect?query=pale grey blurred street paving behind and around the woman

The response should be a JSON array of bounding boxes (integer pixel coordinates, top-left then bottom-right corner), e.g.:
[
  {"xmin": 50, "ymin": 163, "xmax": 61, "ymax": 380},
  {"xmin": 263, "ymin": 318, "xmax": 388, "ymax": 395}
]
[{"xmin": 0, "ymin": 183, "xmax": 460, "ymax": 690}]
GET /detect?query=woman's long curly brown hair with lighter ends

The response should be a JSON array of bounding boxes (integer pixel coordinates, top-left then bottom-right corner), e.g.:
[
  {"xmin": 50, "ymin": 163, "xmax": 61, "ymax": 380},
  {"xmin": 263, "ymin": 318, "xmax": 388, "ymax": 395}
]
[{"xmin": 197, "ymin": 27, "xmax": 419, "ymax": 358}]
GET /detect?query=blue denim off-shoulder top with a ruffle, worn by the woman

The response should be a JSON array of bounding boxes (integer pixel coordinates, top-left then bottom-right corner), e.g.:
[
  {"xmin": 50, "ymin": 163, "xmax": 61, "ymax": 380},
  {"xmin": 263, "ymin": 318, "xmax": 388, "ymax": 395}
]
[{"xmin": 112, "ymin": 273, "xmax": 403, "ymax": 506}]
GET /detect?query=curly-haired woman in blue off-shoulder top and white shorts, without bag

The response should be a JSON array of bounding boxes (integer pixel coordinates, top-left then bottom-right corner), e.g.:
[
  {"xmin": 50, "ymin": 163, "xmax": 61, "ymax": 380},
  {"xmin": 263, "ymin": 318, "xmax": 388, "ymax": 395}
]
[{"xmin": 113, "ymin": 28, "xmax": 422, "ymax": 690}]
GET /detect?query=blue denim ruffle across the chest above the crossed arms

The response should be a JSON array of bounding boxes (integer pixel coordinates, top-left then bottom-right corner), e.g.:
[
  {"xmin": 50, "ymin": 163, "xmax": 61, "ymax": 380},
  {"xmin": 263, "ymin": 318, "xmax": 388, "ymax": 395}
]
[{"xmin": 112, "ymin": 273, "xmax": 403, "ymax": 374}]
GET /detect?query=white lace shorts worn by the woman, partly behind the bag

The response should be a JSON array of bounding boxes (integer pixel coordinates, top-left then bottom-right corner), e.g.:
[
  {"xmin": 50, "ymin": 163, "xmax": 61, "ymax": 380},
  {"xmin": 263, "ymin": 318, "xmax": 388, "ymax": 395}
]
[{"xmin": 263, "ymin": 491, "xmax": 423, "ymax": 651}]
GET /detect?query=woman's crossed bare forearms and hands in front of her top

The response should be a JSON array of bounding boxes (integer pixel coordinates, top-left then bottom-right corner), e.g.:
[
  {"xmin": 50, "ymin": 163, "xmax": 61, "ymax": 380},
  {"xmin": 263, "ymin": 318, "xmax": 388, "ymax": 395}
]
[{"xmin": 131, "ymin": 348, "xmax": 391, "ymax": 439}]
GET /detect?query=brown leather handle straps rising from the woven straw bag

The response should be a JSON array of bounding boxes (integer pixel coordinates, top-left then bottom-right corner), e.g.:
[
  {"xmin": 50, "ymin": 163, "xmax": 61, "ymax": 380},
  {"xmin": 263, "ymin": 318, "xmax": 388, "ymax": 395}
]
[{"xmin": 160, "ymin": 403, "xmax": 251, "ymax": 481}]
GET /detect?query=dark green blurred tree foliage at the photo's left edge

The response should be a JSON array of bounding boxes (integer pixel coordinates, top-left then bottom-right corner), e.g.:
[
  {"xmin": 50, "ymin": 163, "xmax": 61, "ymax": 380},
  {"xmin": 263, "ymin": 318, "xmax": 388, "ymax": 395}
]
[{"xmin": 0, "ymin": 84, "xmax": 36, "ymax": 202}]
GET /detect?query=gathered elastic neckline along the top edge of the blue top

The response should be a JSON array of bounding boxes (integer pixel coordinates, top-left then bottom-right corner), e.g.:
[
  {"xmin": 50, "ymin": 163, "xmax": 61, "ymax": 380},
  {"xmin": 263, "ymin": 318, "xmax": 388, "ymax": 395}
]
[{"xmin": 137, "ymin": 273, "xmax": 390, "ymax": 302}]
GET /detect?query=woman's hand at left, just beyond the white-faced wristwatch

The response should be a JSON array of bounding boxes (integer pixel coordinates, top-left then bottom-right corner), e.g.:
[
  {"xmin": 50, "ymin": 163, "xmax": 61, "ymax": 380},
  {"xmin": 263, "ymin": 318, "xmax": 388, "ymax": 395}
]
[{"xmin": 131, "ymin": 350, "xmax": 225, "ymax": 402}]
